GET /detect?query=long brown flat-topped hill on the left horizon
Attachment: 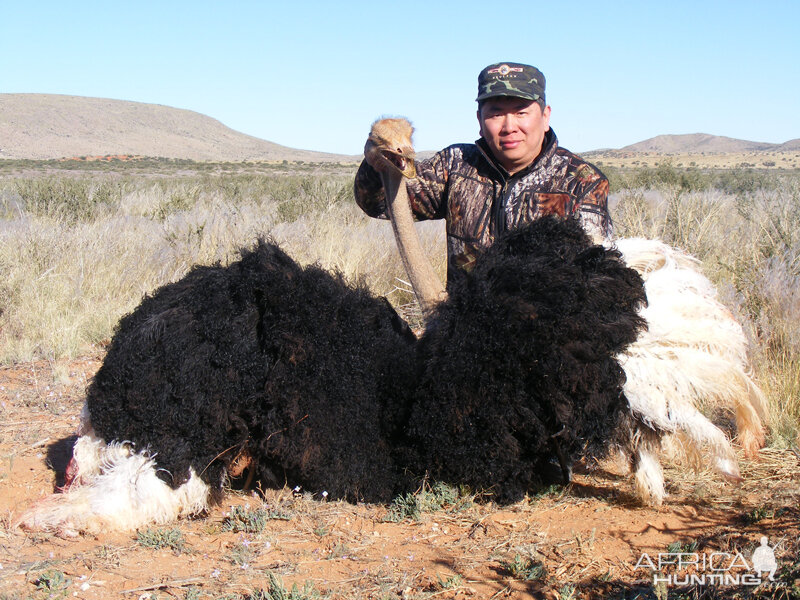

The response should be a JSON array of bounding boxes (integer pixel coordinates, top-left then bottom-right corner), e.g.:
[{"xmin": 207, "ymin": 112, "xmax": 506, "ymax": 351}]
[{"xmin": 0, "ymin": 94, "xmax": 358, "ymax": 162}]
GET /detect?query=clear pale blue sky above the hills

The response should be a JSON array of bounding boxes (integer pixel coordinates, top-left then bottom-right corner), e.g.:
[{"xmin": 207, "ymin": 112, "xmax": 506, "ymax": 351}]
[{"xmin": 0, "ymin": 0, "xmax": 800, "ymax": 154}]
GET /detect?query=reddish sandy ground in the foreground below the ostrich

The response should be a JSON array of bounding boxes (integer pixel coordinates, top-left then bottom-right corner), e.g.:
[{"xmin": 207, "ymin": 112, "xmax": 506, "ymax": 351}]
[{"xmin": 0, "ymin": 357, "xmax": 800, "ymax": 600}]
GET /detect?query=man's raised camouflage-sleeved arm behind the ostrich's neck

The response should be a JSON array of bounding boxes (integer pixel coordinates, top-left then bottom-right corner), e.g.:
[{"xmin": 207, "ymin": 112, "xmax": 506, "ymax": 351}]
[{"xmin": 353, "ymin": 150, "xmax": 447, "ymax": 221}]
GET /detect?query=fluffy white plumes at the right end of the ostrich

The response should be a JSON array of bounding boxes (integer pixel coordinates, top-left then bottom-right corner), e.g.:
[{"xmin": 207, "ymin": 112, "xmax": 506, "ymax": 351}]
[{"xmin": 616, "ymin": 238, "xmax": 769, "ymax": 503}]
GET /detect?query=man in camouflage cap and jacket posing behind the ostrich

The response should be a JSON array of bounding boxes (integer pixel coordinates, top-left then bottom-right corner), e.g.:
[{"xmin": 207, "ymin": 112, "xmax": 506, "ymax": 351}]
[{"xmin": 355, "ymin": 63, "xmax": 611, "ymax": 280}]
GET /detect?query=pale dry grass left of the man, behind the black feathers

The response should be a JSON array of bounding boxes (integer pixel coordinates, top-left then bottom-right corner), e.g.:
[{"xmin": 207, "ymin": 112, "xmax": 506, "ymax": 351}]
[{"xmin": 0, "ymin": 169, "xmax": 444, "ymax": 363}]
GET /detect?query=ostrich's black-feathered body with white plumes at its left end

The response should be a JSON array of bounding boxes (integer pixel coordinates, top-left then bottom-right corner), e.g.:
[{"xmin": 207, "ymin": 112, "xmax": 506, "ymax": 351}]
[{"xmin": 22, "ymin": 123, "xmax": 644, "ymax": 535}]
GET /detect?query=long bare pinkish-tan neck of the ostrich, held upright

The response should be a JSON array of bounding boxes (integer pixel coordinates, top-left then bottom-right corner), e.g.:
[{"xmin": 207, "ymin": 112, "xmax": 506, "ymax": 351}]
[{"xmin": 382, "ymin": 173, "xmax": 446, "ymax": 319}]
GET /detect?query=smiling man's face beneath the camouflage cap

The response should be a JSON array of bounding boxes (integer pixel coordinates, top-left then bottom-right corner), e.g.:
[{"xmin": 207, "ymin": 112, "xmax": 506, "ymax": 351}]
[{"xmin": 478, "ymin": 96, "xmax": 550, "ymax": 174}]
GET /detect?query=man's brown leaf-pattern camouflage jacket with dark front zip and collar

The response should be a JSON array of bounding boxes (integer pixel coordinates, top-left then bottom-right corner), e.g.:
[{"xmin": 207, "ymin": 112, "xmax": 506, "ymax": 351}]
[{"xmin": 355, "ymin": 129, "xmax": 611, "ymax": 280}]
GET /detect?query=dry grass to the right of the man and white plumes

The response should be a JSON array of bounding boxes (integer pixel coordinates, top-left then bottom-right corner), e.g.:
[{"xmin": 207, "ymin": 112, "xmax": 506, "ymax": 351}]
[{"xmin": 612, "ymin": 171, "xmax": 800, "ymax": 447}]
